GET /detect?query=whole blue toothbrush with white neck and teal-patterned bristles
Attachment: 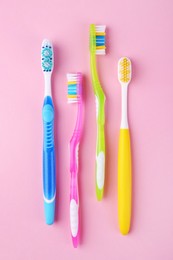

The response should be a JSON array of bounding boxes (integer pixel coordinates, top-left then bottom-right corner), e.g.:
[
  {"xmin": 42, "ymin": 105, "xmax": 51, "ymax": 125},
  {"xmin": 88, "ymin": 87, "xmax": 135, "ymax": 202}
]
[{"xmin": 41, "ymin": 40, "xmax": 56, "ymax": 225}]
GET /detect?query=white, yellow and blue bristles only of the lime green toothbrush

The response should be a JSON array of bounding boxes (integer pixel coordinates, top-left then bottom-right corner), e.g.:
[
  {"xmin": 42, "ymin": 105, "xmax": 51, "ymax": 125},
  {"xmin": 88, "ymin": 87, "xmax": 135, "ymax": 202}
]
[{"xmin": 95, "ymin": 25, "xmax": 106, "ymax": 55}]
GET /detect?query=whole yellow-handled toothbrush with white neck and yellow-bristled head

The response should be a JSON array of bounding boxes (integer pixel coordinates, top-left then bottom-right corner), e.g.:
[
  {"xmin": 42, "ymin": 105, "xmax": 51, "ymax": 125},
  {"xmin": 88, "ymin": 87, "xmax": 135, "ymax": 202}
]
[{"xmin": 118, "ymin": 57, "xmax": 132, "ymax": 235}]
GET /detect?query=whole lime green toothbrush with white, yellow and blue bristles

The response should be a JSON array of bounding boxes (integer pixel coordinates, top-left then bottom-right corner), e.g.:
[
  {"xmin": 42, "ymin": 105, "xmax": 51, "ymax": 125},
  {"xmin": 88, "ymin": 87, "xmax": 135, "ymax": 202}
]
[{"xmin": 90, "ymin": 24, "xmax": 106, "ymax": 200}]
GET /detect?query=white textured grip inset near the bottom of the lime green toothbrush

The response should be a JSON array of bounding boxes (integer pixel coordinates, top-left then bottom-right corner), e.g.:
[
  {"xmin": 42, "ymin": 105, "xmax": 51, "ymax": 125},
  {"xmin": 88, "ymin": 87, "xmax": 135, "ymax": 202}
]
[{"xmin": 96, "ymin": 152, "xmax": 105, "ymax": 189}]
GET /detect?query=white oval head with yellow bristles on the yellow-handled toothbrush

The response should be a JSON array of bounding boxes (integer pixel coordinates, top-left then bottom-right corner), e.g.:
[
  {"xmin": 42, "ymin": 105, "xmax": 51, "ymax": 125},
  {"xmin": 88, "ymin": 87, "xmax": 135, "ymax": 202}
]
[{"xmin": 118, "ymin": 57, "xmax": 132, "ymax": 85}]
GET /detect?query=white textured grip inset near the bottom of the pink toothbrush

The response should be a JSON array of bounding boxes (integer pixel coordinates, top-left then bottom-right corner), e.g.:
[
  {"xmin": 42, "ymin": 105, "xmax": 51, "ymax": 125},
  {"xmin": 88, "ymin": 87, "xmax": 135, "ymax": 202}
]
[{"xmin": 70, "ymin": 199, "xmax": 79, "ymax": 237}]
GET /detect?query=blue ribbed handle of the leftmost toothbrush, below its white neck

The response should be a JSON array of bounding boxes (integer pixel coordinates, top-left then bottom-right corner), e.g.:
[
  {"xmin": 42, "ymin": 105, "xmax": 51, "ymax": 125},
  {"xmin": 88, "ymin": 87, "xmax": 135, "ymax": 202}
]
[{"xmin": 42, "ymin": 96, "xmax": 56, "ymax": 225}]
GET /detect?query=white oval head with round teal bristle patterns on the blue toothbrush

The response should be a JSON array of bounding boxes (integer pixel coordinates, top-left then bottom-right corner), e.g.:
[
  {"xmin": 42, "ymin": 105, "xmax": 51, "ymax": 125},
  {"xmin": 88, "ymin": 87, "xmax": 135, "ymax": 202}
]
[{"xmin": 41, "ymin": 39, "xmax": 54, "ymax": 73}]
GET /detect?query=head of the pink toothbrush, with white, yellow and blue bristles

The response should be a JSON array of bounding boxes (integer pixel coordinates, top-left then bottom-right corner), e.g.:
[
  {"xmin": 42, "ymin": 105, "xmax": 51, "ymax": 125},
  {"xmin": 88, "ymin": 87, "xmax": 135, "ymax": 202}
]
[{"xmin": 67, "ymin": 72, "xmax": 82, "ymax": 103}]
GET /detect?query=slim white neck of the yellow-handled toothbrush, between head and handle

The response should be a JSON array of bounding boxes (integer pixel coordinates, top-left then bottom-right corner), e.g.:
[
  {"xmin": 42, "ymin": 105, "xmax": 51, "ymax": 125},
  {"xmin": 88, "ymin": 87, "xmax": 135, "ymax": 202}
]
[{"xmin": 121, "ymin": 85, "xmax": 129, "ymax": 129}]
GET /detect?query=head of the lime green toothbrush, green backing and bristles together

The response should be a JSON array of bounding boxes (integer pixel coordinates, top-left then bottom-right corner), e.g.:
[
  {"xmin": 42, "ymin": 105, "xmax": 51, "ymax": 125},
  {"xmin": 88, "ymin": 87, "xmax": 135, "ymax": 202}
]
[{"xmin": 90, "ymin": 24, "xmax": 106, "ymax": 55}]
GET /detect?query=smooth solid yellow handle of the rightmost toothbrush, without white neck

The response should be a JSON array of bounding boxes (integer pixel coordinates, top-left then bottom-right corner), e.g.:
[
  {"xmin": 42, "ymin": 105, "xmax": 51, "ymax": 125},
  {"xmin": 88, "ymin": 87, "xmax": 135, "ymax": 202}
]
[{"xmin": 118, "ymin": 129, "xmax": 132, "ymax": 235}]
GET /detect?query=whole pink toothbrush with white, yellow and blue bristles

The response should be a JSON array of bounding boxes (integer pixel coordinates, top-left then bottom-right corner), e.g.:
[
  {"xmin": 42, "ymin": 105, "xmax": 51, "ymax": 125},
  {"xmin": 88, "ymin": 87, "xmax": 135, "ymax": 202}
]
[{"xmin": 67, "ymin": 73, "xmax": 83, "ymax": 247}]
